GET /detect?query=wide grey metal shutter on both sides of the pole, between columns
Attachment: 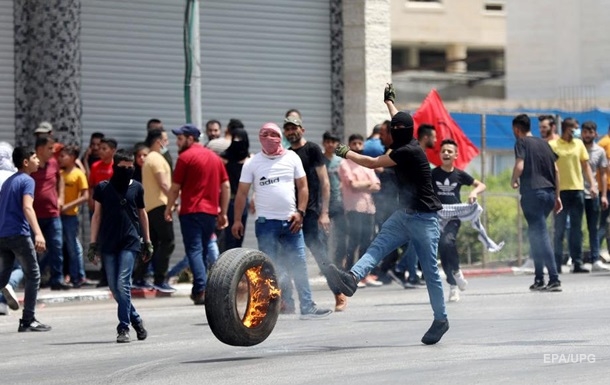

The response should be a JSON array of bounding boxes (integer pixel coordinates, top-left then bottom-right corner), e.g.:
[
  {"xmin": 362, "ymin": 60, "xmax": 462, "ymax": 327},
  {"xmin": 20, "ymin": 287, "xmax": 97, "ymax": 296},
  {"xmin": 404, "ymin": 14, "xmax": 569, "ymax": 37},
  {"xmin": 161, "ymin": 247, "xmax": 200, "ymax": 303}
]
[{"xmin": 80, "ymin": 0, "xmax": 331, "ymax": 262}]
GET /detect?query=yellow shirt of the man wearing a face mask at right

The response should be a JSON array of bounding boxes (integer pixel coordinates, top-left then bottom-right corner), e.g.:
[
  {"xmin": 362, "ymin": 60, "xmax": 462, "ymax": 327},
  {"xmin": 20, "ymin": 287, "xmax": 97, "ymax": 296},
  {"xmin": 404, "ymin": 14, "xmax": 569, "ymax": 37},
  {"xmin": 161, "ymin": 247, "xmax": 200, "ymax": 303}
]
[{"xmin": 549, "ymin": 138, "xmax": 589, "ymax": 191}]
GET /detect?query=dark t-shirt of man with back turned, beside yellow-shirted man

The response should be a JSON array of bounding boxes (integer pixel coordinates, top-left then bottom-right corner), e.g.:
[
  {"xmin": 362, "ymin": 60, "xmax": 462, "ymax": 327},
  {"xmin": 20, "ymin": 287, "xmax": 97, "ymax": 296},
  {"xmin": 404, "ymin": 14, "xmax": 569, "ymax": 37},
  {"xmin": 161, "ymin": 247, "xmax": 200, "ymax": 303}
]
[{"xmin": 515, "ymin": 136, "xmax": 557, "ymax": 194}]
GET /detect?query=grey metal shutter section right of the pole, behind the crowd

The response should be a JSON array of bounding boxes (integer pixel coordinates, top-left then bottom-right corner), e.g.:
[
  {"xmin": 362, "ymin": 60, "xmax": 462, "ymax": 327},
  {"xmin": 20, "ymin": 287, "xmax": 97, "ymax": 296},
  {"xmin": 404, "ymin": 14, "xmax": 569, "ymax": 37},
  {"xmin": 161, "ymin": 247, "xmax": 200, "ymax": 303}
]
[{"xmin": 200, "ymin": 0, "xmax": 331, "ymax": 150}]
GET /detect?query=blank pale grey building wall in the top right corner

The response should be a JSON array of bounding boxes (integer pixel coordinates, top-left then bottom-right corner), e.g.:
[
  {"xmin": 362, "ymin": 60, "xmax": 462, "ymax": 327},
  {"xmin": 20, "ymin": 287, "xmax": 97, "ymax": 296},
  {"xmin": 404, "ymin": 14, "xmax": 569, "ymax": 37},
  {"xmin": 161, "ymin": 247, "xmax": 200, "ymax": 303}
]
[{"xmin": 506, "ymin": 0, "xmax": 610, "ymax": 102}]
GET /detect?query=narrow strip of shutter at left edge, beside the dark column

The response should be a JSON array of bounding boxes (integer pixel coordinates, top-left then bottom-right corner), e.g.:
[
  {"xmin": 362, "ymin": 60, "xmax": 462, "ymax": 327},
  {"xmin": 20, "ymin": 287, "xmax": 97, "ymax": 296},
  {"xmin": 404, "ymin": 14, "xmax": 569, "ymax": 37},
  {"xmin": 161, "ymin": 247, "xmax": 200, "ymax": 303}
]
[{"xmin": 0, "ymin": 0, "xmax": 15, "ymax": 144}]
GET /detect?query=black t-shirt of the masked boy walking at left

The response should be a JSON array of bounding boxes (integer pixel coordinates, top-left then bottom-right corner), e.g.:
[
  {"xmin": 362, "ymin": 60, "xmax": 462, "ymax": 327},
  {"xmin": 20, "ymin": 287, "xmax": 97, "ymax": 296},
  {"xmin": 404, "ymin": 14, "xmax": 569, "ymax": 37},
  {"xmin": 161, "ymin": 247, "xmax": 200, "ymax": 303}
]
[{"xmin": 93, "ymin": 180, "xmax": 144, "ymax": 253}]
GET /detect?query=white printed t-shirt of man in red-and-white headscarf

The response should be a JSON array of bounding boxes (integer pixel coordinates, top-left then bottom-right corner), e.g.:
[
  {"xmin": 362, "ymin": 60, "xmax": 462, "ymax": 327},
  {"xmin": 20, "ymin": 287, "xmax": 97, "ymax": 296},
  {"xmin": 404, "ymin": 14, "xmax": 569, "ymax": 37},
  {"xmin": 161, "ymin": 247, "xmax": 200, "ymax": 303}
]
[{"xmin": 239, "ymin": 151, "xmax": 305, "ymax": 221}]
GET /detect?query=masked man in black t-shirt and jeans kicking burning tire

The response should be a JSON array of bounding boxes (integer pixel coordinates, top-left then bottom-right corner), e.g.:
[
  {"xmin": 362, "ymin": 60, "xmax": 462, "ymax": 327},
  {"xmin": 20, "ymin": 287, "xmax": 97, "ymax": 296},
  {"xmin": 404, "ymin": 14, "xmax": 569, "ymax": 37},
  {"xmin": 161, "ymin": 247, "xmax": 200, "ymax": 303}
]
[{"xmin": 327, "ymin": 85, "xmax": 449, "ymax": 345}]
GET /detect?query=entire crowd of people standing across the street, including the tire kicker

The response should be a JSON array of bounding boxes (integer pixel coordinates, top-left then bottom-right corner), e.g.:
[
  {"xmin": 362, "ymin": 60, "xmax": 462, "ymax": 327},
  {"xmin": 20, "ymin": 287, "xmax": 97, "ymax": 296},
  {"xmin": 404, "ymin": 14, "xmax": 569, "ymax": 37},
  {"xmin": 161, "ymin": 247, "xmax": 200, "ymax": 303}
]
[{"xmin": 0, "ymin": 85, "xmax": 610, "ymax": 344}]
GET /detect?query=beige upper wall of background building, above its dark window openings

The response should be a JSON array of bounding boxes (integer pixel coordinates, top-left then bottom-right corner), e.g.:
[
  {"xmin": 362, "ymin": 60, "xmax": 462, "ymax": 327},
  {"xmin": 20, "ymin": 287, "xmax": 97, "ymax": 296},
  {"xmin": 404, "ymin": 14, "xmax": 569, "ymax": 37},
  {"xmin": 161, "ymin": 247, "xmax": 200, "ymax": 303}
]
[{"xmin": 391, "ymin": 0, "xmax": 508, "ymax": 48}]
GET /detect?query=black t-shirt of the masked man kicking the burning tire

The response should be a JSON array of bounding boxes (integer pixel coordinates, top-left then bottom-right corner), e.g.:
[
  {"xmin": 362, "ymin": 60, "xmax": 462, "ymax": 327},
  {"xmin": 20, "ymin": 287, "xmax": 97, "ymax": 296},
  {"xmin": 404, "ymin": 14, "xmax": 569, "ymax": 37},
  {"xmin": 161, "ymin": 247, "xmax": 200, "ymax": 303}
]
[{"xmin": 389, "ymin": 139, "xmax": 443, "ymax": 213}]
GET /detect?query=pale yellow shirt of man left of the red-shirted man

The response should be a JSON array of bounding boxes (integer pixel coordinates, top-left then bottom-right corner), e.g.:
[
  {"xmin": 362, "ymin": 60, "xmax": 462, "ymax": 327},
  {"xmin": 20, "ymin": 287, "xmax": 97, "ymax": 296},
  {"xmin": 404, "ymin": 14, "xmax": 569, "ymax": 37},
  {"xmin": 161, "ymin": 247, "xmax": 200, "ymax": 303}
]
[{"xmin": 142, "ymin": 151, "xmax": 172, "ymax": 211}]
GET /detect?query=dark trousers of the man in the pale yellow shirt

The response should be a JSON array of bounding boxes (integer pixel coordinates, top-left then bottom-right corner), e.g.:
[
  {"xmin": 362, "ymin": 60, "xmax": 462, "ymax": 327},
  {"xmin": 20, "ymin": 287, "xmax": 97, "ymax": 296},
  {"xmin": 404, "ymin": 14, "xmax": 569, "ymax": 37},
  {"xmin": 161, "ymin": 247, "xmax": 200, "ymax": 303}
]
[{"xmin": 133, "ymin": 205, "xmax": 176, "ymax": 285}]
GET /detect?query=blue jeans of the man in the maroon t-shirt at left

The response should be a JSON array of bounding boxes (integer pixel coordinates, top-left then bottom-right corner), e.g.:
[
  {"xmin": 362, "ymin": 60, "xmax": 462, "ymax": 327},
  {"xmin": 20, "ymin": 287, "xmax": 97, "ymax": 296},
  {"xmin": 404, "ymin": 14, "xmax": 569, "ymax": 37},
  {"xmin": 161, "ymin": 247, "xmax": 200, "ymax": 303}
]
[{"xmin": 38, "ymin": 217, "xmax": 64, "ymax": 285}]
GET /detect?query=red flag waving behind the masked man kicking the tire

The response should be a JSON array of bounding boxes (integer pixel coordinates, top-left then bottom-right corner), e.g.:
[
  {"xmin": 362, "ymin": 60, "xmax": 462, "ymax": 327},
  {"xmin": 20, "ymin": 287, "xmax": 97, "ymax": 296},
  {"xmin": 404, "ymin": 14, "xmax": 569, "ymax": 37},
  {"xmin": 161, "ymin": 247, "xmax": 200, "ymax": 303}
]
[{"xmin": 413, "ymin": 89, "xmax": 479, "ymax": 170}]
